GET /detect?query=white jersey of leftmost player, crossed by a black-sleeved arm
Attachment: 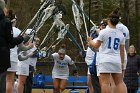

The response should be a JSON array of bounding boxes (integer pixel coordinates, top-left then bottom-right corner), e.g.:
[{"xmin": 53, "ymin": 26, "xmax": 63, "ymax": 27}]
[{"xmin": 10, "ymin": 27, "xmax": 21, "ymax": 62}]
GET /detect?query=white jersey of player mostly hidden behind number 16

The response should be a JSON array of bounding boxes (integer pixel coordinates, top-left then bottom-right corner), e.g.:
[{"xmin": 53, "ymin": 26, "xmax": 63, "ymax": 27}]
[{"xmin": 116, "ymin": 23, "xmax": 130, "ymax": 61}]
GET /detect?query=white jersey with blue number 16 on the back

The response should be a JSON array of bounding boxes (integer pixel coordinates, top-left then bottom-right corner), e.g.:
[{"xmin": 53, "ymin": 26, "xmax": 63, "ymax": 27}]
[{"xmin": 98, "ymin": 27, "xmax": 125, "ymax": 64}]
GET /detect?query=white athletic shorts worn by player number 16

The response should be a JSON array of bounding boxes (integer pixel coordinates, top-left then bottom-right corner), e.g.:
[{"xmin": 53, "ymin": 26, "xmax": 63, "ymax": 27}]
[{"xmin": 97, "ymin": 62, "xmax": 122, "ymax": 75}]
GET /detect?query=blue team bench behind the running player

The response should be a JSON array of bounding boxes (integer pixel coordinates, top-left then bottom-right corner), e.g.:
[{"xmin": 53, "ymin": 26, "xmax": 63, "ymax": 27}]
[{"xmin": 32, "ymin": 75, "xmax": 88, "ymax": 91}]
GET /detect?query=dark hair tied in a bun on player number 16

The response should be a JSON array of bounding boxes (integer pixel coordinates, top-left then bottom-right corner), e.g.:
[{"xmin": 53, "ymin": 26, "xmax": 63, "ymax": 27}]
[{"xmin": 108, "ymin": 8, "xmax": 120, "ymax": 26}]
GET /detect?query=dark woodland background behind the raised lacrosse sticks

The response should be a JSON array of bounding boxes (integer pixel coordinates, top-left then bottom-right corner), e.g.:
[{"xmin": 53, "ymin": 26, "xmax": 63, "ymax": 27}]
[{"xmin": 8, "ymin": 0, "xmax": 140, "ymax": 61}]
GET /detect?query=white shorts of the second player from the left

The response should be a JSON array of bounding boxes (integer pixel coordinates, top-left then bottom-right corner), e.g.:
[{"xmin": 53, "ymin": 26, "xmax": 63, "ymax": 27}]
[{"xmin": 16, "ymin": 62, "xmax": 29, "ymax": 76}]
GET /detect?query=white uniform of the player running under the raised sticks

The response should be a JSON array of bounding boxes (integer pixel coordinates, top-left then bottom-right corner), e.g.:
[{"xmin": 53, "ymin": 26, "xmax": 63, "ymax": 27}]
[{"xmin": 52, "ymin": 53, "xmax": 74, "ymax": 79}]
